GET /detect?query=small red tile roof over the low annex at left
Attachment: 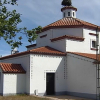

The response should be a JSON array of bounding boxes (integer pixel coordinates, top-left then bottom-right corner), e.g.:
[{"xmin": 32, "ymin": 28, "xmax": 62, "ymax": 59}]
[{"xmin": 0, "ymin": 63, "xmax": 26, "ymax": 73}]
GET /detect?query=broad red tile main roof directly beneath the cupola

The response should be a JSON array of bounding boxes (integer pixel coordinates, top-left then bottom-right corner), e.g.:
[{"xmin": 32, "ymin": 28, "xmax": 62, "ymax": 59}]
[{"xmin": 39, "ymin": 17, "xmax": 100, "ymax": 32}]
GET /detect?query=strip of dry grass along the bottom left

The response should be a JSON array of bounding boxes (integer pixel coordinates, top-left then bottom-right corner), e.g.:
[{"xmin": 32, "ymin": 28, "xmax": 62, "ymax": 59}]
[{"xmin": 0, "ymin": 95, "xmax": 49, "ymax": 100}]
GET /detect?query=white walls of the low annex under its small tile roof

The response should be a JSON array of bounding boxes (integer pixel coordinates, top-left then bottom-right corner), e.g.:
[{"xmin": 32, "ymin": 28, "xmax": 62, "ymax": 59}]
[{"xmin": 3, "ymin": 74, "xmax": 26, "ymax": 95}]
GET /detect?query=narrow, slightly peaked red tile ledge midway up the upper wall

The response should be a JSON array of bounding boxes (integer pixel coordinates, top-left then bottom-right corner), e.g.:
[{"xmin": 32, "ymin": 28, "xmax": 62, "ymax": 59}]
[{"xmin": 51, "ymin": 35, "xmax": 84, "ymax": 42}]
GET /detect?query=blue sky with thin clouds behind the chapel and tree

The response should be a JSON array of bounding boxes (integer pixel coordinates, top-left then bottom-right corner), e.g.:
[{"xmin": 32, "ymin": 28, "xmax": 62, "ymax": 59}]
[{"xmin": 0, "ymin": 0, "xmax": 100, "ymax": 56}]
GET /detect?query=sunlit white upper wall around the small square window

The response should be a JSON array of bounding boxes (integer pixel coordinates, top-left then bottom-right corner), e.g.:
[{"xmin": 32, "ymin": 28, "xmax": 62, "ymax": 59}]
[{"xmin": 66, "ymin": 29, "xmax": 99, "ymax": 54}]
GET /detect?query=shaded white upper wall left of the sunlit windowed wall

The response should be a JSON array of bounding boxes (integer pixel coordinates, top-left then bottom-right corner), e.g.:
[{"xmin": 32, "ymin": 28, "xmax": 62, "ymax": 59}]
[{"xmin": 27, "ymin": 28, "xmax": 83, "ymax": 52}]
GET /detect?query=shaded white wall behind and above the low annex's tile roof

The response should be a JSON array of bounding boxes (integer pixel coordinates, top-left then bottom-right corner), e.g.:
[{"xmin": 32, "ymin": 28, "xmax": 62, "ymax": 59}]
[{"xmin": 1, "ymin": 55, "xmax": 30, "ymax": 93}]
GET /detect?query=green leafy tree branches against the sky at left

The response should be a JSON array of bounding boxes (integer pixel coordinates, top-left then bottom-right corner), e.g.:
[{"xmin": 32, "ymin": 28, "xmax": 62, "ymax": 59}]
[{"xmin": 0, "ymin": 0, "xmax": 41, "ymax": 49}]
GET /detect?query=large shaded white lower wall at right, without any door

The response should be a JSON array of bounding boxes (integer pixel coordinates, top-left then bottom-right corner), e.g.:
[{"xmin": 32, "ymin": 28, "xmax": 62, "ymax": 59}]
[{"xmin": 66, "ymin": 53, "xmax": 96, "ymax": 94}]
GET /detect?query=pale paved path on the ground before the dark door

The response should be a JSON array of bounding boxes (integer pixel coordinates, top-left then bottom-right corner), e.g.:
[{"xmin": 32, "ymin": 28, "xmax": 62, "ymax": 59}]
[{"xmin": 45, "ymin": 95, "xmax": 92, "ymax": 100}]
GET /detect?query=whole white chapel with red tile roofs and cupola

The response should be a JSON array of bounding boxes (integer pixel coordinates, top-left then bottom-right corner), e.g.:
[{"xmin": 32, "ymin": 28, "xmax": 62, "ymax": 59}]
[{"xmin": 0, "ymin": 0, "xmax": 100, "ymax": 99}]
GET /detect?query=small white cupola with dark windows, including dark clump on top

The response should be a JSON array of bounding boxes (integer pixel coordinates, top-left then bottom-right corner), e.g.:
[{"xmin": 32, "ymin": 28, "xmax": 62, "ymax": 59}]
[{"xmin": 61, "ymin": 0, "xmax": 77, "ymax": 18}]
